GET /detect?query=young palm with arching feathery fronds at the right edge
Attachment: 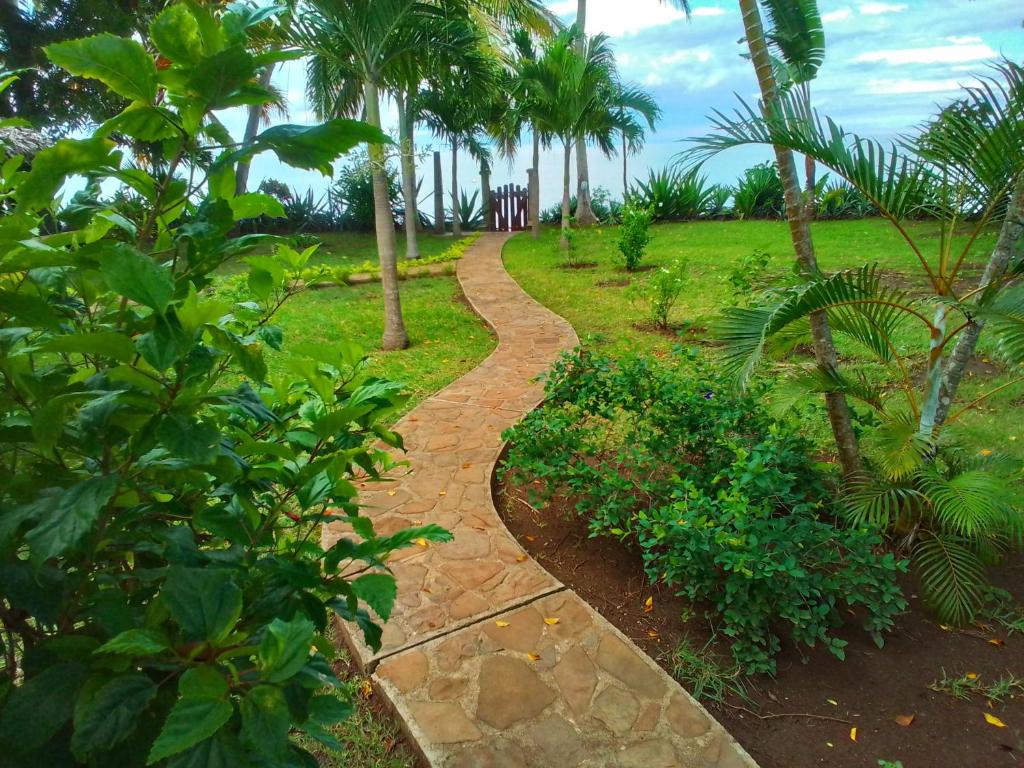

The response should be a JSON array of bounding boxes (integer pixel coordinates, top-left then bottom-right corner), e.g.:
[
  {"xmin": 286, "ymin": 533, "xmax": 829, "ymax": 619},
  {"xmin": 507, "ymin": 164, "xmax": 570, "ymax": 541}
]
[{"xmin": 698, "ymin": 61, "xmax": 1024, "ymax": 624}]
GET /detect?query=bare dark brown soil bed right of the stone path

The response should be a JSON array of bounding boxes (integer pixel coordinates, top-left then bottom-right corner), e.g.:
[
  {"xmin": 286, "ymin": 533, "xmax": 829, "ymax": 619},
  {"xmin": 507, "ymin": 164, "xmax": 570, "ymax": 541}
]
[{"xmin": 495, "ymin": 475, "xmax": 1024, "ymax": 768}]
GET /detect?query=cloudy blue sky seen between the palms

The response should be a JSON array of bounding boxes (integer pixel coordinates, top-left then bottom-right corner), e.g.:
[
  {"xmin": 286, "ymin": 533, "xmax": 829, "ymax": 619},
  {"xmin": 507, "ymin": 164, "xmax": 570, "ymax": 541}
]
[{"xmin": 225, "ymin": 0, "xmax": 1024, "ymax": 206}]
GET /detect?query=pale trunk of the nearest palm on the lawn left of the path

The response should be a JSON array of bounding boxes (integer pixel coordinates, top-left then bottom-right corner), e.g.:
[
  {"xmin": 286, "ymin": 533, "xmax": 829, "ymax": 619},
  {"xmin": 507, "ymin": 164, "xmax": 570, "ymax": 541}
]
[{"xmin": 362, "ymin": 80, "xmax": 409, "ymax": 350}]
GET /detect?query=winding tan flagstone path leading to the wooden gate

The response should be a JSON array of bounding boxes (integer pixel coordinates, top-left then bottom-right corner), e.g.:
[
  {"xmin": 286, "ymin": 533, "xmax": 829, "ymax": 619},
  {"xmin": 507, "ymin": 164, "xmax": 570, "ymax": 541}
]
[{"xmin": 325, "ymin": 234, "xmax": 757, "ymax": 768}]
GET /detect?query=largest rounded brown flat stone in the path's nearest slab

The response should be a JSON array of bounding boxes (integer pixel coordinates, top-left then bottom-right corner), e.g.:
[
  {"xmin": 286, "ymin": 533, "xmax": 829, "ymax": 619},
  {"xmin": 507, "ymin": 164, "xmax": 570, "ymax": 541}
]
[{"xmin": 476, "ymin": 656, "xmax": 555, "ymax": 729}]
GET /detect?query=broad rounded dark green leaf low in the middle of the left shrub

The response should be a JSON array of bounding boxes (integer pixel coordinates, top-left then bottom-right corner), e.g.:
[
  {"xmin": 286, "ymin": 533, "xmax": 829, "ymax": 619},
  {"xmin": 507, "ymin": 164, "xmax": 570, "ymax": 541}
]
[{"xmin": 162, "ymin": 567, "xmax": 242, "ymax": 644}]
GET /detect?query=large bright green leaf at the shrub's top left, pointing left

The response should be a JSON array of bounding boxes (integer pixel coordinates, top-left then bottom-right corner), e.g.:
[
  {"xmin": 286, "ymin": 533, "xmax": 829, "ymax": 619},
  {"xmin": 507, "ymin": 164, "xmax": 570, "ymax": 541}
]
[{"xmin": 43, "ymin": 33, "xmax": 157, "ymax": 101}]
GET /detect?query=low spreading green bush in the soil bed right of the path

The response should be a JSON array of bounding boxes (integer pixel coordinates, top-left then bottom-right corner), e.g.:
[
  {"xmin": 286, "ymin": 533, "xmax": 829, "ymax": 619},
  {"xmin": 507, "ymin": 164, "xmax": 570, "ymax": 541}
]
[{"xmin": 502, "ymin": 351, "xmax": 906, "ymax": 673}]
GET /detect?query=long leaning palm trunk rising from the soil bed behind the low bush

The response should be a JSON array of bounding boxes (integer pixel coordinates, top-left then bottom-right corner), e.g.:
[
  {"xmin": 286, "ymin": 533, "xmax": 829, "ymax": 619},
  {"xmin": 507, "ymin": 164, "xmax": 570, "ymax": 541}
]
[{"xmin": 739, "ymin": 0, "xmax": 861, "ymax": 477}]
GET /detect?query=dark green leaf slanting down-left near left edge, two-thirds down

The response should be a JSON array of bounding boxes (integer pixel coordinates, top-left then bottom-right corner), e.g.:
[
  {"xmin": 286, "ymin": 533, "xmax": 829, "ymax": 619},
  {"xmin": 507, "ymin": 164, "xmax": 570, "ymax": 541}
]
[{"xmin": 26, "ymin": 475, "xmax": 118, "ymax": 562}]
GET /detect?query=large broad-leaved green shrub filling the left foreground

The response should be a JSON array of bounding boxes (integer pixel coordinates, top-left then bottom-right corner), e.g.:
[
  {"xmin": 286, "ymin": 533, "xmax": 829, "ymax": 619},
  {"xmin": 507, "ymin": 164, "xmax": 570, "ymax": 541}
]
[{"xmin": 0, "ymin": 3, "xmax": 449, "ymax": 768}]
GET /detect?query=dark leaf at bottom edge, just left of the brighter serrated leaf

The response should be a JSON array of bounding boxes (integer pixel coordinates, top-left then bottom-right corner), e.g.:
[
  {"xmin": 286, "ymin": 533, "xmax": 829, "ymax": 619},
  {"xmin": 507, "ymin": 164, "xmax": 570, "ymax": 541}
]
[{"xmin": 71, "ymin": 673, "xmax": 157, "ymax": 762}]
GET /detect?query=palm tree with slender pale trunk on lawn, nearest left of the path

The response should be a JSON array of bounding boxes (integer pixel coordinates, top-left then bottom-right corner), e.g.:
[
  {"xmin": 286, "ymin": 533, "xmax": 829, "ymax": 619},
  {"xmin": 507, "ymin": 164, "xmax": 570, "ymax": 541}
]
[{"xmin": 295, "ymin": 0, "xmax": 437, "ymax": 350}]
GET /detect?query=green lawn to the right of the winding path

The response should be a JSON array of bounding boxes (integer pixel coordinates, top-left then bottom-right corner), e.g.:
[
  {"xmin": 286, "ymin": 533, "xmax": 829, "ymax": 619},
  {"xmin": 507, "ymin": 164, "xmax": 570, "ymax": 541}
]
[{"xmin": 504, "ymin": 219, "xmax": 1024, "ymax": 460}]
